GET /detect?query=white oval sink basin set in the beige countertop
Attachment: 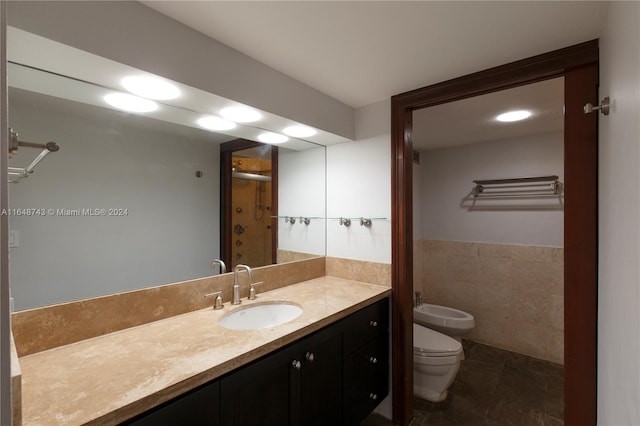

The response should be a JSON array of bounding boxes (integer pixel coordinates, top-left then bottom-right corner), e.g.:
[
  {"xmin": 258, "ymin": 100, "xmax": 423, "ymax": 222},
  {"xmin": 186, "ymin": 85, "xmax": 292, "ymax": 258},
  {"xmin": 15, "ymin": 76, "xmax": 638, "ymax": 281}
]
[{"xmin": 218, "ymin": 302, "xmax": 302, "ymax": 330}]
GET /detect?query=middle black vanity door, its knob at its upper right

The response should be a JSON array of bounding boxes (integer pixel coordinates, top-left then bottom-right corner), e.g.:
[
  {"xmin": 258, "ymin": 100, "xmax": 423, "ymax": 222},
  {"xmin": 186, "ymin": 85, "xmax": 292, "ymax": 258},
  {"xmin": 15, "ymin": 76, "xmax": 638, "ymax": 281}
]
[{"xmin": 220, "ymin": 347, "xmax": 296, "ymax": 426}]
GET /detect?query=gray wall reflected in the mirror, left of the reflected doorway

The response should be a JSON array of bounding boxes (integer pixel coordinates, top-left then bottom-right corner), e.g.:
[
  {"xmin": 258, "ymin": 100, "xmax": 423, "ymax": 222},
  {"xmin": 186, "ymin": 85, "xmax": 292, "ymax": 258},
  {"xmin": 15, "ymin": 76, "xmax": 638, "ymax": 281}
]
[{"xmin": 9, "ymin": 104, "xmax": 220, "ymax": 310}]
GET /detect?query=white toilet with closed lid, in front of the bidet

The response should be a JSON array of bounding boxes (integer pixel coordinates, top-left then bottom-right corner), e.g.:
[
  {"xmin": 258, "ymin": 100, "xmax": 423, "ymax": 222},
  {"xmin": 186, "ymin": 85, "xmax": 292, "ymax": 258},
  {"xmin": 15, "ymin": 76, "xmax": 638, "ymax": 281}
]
[{"xmin": 413, "ymin": 323, "xmax": 462, "ymax": 402}]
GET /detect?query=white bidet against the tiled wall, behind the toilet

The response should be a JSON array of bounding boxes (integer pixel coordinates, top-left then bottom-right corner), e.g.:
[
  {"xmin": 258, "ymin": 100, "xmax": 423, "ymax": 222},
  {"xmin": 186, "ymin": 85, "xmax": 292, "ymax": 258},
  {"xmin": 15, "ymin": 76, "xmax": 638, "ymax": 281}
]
[{"xmin": 413, "ymin": 303, "xmax": 476, "ymax": 340}]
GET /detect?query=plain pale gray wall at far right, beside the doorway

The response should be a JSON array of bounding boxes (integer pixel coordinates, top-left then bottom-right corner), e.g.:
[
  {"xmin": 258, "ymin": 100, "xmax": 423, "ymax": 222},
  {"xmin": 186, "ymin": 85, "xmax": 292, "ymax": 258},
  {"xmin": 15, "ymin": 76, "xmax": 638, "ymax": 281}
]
[{"xmin": 598, "ymin": 1, "xmax": 640, "ymax": 425}]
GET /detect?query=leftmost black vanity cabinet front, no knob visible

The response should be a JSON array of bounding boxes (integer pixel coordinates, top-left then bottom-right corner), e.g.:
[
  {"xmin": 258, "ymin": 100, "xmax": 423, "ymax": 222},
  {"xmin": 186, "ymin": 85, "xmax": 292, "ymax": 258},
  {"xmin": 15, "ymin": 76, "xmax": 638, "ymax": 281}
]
[{"xmin": 124, "ymin": 381, "xmax": 220, "ymax": 426}]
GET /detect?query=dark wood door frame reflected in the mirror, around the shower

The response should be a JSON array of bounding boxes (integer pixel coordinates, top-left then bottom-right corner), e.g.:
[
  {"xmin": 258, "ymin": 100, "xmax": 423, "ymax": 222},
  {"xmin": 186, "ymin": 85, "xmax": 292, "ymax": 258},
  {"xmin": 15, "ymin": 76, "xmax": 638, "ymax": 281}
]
[{"xmin": 220, "ymin": 139, "xmax": 278, "ymax": 268}]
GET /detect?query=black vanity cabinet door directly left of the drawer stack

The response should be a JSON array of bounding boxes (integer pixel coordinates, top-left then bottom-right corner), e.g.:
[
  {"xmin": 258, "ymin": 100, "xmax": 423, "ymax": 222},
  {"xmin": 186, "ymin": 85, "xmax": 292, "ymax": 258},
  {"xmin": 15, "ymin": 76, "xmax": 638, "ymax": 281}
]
[{"xmin": 300, "ymin": 322, "xmax": 343, "ymax": 426}]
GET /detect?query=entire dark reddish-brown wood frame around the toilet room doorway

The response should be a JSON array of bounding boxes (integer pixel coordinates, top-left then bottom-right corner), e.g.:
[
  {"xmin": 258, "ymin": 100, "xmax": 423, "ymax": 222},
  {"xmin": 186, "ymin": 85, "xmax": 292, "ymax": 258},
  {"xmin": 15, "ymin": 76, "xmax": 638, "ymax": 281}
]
[{"xmin": 391, "ymin": 40, "xmax": 599, "ymax": 426}]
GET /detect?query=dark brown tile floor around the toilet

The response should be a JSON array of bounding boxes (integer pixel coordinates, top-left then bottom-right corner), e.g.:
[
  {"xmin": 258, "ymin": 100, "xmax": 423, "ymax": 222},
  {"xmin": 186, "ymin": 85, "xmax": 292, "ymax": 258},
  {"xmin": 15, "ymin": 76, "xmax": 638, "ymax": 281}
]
[{"xmin": 361, "ymin": 340, "xmax": 564, "ymax": 426}]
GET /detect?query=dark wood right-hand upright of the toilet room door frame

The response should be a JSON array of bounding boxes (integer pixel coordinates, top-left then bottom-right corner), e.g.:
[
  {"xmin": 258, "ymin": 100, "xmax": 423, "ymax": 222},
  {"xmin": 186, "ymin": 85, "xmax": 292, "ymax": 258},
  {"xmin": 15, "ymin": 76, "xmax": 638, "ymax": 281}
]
[{"xmin": 564, "ymin": 64, "xmax": 598, "ymax": 426}]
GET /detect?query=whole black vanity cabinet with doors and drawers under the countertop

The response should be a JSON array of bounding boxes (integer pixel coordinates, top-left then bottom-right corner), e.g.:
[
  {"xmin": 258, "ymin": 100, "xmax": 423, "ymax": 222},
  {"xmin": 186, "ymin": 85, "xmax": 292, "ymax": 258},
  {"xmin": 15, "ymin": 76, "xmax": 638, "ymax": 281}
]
[{"xmin": 122, "ymin": 298, "xmax": 389, "ymax": 426}]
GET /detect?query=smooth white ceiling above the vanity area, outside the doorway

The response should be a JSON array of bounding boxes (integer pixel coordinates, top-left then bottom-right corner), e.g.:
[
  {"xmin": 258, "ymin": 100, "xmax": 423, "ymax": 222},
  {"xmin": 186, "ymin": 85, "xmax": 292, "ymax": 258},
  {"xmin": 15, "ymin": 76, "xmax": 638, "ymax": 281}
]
[{"xmin": 143, "ymin": 1, "xmax": 607, "ymax": 108}]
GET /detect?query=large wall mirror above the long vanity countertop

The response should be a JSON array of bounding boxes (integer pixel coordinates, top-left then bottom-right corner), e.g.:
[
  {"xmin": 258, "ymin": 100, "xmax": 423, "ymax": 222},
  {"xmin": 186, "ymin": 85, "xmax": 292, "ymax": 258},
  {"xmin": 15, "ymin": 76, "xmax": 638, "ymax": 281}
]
[{"xmin": 8, "ymin": 28, "xmax": 326, "ymax": 310}]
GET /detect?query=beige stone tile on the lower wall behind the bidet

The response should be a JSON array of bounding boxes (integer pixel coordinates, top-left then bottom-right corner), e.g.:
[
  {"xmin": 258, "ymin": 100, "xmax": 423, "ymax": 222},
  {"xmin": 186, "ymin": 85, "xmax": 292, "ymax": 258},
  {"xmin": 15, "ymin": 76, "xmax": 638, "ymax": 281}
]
[{"xmin": 414, "ymin": 240, "xmax": 564, "ymax": 363}]
